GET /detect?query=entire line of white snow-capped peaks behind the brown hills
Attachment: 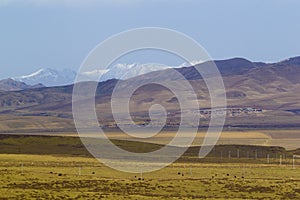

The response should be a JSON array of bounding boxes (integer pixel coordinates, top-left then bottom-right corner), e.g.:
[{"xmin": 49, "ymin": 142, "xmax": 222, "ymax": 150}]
[{"xmin": 12, "ymin": 61, "xmax": 204, "ymax": 87}]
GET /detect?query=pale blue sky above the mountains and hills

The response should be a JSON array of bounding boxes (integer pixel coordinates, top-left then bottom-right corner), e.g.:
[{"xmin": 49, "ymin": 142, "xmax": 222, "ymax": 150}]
[{"xmin": 0, "ymin": 0, "xmax": 300, "ymax": 79}]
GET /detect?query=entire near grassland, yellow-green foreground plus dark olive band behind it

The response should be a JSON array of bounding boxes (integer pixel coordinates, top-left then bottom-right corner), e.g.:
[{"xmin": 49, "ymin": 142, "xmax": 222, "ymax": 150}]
[{"xmin": 0, "ymin": 135, "xmax": 300, "ymax": 199}]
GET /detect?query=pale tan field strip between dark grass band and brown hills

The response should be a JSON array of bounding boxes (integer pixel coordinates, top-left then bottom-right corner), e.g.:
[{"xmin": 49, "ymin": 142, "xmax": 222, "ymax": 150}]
[{"xmin": 96, "ymin": 129, "xmax": 300, "ymax": 150}]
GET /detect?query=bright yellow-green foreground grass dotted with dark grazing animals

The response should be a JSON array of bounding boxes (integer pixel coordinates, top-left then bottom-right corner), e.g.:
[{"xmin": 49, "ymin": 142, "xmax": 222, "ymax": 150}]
[{"xmin": 0, "ymin": 154, "xmax": 300, "ymax": 199}]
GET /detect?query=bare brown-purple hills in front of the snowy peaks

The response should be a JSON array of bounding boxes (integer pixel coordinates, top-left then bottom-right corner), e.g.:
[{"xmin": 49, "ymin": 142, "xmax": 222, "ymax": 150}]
[{"xmin": 0, "ymin": 57, "xmax": 300, "ymax": 132}]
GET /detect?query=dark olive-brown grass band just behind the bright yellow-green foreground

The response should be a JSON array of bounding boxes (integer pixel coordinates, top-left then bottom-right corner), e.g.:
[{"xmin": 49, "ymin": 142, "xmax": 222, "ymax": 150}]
[{"xmin": 0, "ymin": 135, "xmax": 298, "ymax": 163}]
